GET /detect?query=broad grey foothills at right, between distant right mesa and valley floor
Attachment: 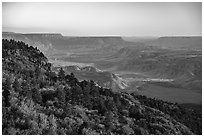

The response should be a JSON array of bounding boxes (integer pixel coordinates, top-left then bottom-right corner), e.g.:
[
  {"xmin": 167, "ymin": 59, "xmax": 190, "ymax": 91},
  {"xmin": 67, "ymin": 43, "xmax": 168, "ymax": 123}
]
[{"xmin": 97, "ymin": 47, "xmax": 202, "ymax": 90}]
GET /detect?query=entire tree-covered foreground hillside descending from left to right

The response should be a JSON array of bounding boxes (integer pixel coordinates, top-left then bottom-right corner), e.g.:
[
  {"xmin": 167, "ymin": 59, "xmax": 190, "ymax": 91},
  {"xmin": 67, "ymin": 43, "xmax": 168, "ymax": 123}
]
[{"xmin": 2, "ymin": 39, "xmax": 202, "ymax": 135}]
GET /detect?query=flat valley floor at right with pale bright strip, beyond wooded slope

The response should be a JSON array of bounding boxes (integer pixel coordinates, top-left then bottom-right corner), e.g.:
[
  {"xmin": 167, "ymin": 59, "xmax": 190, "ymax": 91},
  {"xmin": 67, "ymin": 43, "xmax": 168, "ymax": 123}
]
[{"xmin": 115, "ymin": 72, "xmax": 202, "ymax": 104}]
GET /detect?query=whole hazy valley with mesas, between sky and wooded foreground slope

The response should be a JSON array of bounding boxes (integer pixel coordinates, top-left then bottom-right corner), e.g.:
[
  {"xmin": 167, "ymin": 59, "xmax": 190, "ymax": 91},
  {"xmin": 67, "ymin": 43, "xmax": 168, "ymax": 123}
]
[{"xmin": 3, "ymin": 32, "xmax": 202, "ymax": 104}]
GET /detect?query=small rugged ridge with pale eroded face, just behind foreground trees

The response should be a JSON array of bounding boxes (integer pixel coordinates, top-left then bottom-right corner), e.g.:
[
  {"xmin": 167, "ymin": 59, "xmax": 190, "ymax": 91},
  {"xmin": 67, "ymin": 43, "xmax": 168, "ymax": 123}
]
[{"xmin": 52, "ymin": 66, "xmax": 127, "ymax": 91}]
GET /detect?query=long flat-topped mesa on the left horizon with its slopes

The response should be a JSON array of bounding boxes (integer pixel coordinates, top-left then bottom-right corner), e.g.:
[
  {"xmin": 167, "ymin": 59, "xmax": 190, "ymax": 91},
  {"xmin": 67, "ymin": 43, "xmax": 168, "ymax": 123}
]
[{"xmin": 2, "ymin": 32, "xmax": 133, "ymax": 55}]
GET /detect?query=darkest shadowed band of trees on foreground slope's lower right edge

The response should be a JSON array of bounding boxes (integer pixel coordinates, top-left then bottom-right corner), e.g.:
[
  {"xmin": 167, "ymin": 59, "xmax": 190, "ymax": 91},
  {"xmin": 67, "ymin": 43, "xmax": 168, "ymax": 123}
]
[{"xmin": 133, "ymin": 95, "xmax": 202, "ymax": 135}]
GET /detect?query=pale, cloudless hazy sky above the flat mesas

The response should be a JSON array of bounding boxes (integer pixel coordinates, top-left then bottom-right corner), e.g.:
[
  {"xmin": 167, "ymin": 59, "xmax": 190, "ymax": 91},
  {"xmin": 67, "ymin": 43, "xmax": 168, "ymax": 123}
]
[{"xmin": 2, "ymin": 2, "xmax": 202, "ymax": 36}]
